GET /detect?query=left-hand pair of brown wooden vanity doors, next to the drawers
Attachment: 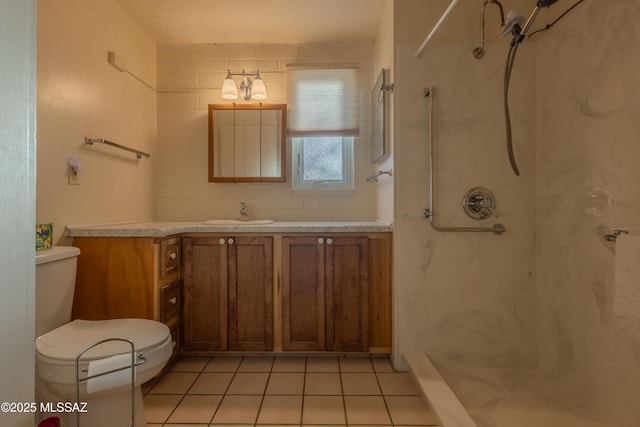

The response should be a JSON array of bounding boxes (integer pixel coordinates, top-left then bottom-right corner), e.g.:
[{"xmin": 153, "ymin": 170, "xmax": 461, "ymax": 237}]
[{"xmin": 182, "ymin": 236, "xmax": 273, "ymax": 354}]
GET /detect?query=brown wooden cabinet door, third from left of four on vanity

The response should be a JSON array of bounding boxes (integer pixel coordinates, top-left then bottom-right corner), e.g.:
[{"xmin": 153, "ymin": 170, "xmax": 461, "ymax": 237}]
[{"xmin": 282, "ymin": 236, "xmax": 325, "ymax": 351}]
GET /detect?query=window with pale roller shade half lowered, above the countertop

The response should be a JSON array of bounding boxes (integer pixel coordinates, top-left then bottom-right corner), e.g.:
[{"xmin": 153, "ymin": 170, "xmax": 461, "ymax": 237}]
[{"xmin": 287, "ymin": 66, "xmax": 358, "ymax": 189}]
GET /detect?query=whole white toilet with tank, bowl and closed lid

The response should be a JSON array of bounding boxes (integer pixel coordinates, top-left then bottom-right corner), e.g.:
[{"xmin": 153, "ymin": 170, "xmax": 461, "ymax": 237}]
[{"xmin": 36, "ymin": 246, "xmax": 173, "ymax": 427}]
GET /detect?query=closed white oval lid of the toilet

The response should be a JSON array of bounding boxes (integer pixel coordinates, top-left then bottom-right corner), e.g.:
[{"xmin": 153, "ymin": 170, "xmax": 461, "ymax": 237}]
[{"xmin": 36, "ymin": 319, "xmax": 169, "ymax": 360}]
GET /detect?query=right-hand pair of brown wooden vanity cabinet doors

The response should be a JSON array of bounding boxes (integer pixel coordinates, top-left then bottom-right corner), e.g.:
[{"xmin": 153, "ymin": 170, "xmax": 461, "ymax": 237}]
[{"xmin": 282, "ymin": 236, "xmax": 369, "ymax": 351}]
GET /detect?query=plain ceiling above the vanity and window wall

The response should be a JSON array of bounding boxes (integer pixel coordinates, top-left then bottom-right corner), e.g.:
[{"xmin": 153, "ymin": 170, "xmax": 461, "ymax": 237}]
[{"xmin": 117, "ymin": 0, "xmax": 389, "ymax": 44}]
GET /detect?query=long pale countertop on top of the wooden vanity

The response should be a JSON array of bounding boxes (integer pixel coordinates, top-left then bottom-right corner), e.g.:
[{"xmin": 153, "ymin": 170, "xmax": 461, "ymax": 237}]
[{"xmin": 66, "ymin": 221, "xmax": 393, "ymax": 237}]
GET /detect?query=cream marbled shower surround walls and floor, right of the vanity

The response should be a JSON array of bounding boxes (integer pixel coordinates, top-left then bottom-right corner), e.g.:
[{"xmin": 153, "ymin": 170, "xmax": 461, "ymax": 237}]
[{"xmin": 394, "ymin": 0, "xmax": 640, "ymax": 427}]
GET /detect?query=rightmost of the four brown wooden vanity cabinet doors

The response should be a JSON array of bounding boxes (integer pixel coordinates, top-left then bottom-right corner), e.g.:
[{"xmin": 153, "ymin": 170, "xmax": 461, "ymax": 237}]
[{"xmin": 325, "ymin": 237, "xmax": 369, "ymax": 351}]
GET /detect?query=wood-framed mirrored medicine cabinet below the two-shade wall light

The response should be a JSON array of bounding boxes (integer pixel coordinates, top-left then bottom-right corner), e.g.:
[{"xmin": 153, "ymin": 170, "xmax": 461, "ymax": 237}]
[{"xmin": 209, "ymin": 103, "xmax": 287, "ymax": 182}]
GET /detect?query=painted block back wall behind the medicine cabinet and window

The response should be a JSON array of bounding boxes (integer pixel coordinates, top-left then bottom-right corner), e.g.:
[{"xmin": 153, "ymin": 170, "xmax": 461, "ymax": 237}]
[{"xmin": 156, "ymin": 43, "xmax": 375, "ymax": 220}]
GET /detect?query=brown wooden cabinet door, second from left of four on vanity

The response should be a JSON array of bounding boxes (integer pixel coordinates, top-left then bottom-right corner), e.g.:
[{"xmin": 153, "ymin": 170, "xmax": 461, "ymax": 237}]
[{"xmin": 228, "ymin": 236, "xmax": 273, "ymax": 351}]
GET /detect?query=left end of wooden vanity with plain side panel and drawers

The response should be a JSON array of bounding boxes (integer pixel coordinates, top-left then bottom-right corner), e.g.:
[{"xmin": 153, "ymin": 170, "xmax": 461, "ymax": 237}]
[{"xmin": 72, "ymin": 236, "xmax": 182, "ymax": 368}]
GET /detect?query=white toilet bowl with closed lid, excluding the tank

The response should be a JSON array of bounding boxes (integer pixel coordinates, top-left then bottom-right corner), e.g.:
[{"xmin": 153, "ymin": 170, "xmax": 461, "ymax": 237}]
[{"xmin": 36, "ymin": 319, "xmax": 173, "ymax": 427}]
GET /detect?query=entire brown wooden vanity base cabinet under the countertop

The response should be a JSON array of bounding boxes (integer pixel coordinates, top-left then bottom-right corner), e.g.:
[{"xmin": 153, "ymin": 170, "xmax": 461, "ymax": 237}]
[{"xmin": 73, "ymin": 233, "xmax": 392, "ymax": 358}]
